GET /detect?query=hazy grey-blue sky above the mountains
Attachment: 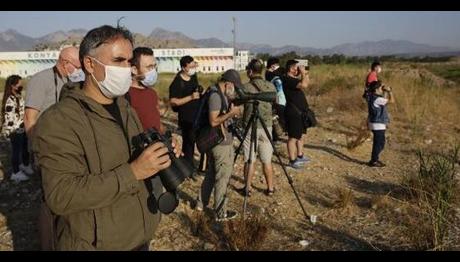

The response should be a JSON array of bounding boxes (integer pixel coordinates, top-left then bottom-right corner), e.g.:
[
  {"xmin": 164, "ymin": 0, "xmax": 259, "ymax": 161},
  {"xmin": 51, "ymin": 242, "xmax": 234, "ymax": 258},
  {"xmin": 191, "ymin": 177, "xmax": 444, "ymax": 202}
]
[{"xmin": 0, "ymin": 11, "xmax": 460, "ymax": 48}]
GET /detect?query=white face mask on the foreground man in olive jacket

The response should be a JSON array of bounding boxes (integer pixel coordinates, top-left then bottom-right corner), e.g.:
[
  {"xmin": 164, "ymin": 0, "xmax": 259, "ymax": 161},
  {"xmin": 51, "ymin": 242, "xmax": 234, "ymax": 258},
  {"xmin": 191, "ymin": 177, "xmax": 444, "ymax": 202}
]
[{"xmin": 91, "ymin": 57, "xmax": 132, "ymax": 98}]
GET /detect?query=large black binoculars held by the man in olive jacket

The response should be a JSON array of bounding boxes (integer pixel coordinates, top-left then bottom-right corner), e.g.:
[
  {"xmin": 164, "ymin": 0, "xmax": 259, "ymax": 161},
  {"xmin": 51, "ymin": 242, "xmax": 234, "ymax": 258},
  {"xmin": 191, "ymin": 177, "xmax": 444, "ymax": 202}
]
[{"xmin": 133, "ymin": 128, "xmax": 193, "ymax": 214}]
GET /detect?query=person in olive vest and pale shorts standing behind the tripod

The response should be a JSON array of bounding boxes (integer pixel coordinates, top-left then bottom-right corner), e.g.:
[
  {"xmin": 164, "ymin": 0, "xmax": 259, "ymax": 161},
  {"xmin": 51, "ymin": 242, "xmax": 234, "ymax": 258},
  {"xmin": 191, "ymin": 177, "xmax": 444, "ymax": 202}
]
[{"xmin": 240, "ymin": 59, "xmax": 276, "ymax": 196}]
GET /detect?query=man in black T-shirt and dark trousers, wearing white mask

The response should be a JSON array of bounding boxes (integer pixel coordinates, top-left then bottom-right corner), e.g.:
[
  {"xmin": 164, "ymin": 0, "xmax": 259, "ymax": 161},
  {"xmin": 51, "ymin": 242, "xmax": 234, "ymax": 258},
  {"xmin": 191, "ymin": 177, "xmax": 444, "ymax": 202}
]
[{"xmin": 169, "ymin": 56, "xmax": 201, "ymax": 169}]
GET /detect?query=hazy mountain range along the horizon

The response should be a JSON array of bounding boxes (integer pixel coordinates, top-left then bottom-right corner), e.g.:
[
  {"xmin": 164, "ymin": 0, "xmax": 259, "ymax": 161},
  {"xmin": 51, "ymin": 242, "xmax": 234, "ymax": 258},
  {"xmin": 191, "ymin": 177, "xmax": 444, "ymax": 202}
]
[{"xmin": 0, "ymin": 28, "xmax": 460, "ymax": 56}]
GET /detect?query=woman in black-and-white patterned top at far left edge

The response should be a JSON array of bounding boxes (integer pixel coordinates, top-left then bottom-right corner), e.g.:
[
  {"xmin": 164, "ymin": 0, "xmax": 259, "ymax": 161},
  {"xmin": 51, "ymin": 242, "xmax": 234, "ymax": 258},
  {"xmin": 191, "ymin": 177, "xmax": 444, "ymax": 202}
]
[{"xmin": 1, "ymin": 75, "xmax": 34, "ymax": 182}]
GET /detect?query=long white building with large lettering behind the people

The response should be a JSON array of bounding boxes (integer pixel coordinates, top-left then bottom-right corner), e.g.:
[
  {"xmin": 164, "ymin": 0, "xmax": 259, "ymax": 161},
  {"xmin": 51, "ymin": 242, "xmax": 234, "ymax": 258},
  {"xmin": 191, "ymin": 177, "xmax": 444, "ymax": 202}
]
[{"xmin": 0, "ymin": 48, "xmax": 249, "ymax": 78}]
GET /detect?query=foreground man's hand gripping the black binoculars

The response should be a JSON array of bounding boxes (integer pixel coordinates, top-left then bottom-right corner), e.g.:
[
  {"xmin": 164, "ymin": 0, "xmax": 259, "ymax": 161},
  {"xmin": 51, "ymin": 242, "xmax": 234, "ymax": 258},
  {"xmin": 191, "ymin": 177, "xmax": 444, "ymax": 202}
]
[{"xmin": 130, "ymin": 142, "xmax": 171, "ymax": 180}]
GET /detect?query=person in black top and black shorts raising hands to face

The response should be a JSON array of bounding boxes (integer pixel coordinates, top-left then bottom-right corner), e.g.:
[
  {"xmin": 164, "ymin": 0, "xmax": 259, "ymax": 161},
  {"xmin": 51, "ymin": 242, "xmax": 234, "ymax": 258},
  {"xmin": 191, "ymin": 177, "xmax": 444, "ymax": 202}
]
[{"xmin": 282, "ymin": 60, "xmax": 309, "ymax": 169}]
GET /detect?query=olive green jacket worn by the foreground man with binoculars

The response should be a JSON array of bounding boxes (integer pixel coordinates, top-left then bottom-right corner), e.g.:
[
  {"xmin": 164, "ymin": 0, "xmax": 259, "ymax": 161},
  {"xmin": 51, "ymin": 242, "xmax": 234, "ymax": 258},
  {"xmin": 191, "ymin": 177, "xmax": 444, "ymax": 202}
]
[{"xmin": 33, "ymin": 83, "xmax": 163, "ymax": 250}]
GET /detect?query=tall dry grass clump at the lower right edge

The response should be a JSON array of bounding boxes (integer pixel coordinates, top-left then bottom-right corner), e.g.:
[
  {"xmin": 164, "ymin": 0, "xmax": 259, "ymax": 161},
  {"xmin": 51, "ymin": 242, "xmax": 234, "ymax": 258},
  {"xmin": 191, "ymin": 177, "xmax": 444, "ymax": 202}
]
[{"xmin": 403, "ymin": 146, "xmax": 460, "ymax": 250}]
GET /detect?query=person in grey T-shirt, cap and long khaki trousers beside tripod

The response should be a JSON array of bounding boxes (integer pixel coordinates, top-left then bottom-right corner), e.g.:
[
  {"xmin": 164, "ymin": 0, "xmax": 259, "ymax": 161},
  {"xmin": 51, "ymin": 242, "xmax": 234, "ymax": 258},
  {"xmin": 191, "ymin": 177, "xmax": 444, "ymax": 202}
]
[{"xmin": 196, "ymin": 69, "xmax": 243, "ymax": 221}]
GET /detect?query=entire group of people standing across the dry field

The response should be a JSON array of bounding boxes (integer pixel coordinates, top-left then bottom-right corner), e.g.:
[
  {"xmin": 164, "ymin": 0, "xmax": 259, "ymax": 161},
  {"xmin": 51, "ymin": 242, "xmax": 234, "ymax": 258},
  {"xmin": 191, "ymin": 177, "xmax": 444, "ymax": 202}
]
[{"xmin": 2, "ymin": 25, "xmax": 392, "ymax": 250}]
